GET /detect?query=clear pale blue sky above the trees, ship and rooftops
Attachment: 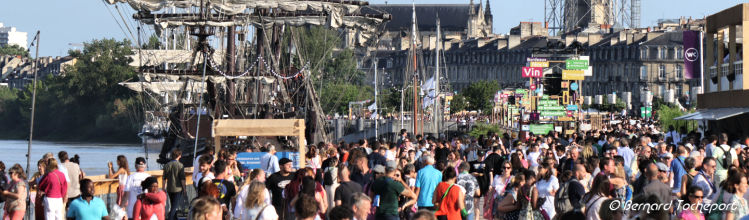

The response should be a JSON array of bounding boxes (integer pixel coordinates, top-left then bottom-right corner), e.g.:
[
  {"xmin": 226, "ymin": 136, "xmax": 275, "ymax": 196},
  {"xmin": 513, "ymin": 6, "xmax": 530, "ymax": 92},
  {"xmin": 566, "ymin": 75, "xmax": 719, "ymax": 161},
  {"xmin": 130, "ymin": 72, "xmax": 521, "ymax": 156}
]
[{"xmin": 0, "ymin": 0, "xmax": 747, "ymax": 56}]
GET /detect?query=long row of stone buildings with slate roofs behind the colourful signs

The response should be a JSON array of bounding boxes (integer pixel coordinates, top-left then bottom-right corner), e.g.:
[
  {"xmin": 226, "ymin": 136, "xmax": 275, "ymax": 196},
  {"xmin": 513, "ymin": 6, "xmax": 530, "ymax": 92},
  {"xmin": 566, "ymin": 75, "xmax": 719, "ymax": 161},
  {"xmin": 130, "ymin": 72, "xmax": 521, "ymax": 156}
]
[{"xmin": 372, "ymin": 20, "xmax": 700, "ymax": 108}]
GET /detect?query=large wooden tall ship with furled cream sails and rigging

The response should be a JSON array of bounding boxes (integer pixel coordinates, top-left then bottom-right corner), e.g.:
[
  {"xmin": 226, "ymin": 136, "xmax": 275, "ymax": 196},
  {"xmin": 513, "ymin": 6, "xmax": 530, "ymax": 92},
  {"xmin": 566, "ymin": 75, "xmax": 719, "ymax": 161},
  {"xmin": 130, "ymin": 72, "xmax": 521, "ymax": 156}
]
[{"xmin": 106, "ymin": 0, "xmax": 390, "ymax": 166}]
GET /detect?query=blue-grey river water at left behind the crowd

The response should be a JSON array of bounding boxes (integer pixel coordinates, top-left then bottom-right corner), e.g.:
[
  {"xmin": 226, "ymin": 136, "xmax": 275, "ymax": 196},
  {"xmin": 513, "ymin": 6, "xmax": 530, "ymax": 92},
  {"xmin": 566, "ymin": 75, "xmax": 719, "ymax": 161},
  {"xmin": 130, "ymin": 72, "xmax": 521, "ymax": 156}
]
[{"xmin": 0, "ymin": 140, "xmax": 160, "ymax": 176}]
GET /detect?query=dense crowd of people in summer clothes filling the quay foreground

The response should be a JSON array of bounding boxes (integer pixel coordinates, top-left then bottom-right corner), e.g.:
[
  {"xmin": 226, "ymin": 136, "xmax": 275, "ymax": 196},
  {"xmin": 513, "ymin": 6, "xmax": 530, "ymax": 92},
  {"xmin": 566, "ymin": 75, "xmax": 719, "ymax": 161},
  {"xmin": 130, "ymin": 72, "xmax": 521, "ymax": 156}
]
[{"xmin": 0, "ymin": 120, "xmax": 749, "ymax": 220}]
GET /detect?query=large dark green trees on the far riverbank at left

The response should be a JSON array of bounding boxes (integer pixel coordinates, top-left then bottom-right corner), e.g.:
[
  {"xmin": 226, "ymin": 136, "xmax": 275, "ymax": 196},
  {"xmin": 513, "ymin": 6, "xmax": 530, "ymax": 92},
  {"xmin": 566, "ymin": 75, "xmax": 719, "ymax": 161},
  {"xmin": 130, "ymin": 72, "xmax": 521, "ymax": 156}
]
[{"xmin": 0, "ymin": 39, "xmax": 141, "ymax": 141}]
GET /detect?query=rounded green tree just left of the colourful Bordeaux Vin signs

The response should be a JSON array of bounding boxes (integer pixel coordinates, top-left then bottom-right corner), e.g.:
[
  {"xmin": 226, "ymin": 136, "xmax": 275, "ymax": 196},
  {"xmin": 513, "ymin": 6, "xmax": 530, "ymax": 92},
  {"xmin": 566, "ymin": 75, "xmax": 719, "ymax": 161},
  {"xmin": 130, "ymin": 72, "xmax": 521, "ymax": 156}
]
[{"xmin": 462, "ymin": 80, "xmax": 499, "ymax": 112}]
